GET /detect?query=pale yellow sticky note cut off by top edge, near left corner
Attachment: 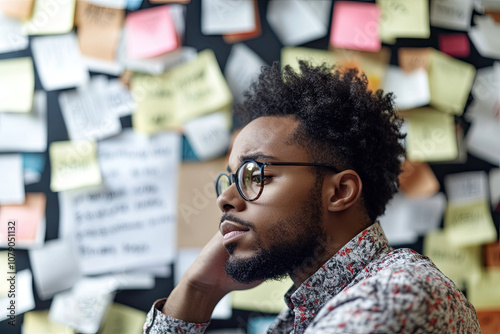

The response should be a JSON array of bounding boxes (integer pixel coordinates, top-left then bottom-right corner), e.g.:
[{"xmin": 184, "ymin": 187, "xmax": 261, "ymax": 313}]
[{"xmin": 23, "ymin": 0, "xmax": 76, "ymax": 35}]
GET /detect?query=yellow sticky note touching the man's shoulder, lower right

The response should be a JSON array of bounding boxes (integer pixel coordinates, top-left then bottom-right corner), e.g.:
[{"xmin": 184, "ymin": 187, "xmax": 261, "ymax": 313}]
[{"xmin": 423, "ymin": 230, "xmax": 481, "ymax": 289}]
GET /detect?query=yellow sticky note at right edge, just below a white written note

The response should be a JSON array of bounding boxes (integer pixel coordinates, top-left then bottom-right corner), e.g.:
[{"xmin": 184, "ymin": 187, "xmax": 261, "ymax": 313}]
[{"xmin": 444, "ymin": 200, "xmax": 497, "ymax": 246}]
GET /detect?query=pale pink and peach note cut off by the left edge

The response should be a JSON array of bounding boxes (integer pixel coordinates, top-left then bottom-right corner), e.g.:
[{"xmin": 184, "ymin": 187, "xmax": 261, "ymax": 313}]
[{"xmin": 0, "ymin": 193, "xmax": 46, "ymax": 249}]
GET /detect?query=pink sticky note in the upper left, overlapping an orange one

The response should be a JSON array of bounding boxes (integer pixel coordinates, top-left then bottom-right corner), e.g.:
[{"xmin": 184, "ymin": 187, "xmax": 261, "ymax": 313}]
[{"xmin": 126, "ymin": 6, "xmax": 179, "ymax": 58}]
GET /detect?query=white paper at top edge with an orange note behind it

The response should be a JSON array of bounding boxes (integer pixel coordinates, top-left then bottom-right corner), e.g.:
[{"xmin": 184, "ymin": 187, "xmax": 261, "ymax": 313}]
[{"xmin": 201, "ymin": 0, "xmax": 255, "ymax": 35}]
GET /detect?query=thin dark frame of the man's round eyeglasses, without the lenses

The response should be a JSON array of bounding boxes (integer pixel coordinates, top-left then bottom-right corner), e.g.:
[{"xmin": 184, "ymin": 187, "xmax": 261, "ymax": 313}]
[{"xmin": 214, "ymin": 159, "xmax": 341, "ymax": 202}]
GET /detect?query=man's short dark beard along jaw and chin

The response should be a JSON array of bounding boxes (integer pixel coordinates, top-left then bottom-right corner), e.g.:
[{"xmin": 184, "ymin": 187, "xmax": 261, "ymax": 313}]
[{"xmin": 225, "ymin": 187, "xmax": 326, "ymax": 283}]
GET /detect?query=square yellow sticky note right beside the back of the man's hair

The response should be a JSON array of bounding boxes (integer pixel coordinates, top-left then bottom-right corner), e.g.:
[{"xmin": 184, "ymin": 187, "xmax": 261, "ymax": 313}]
[{"xmin": 404, "ymin": 108, "xmax": 458, "ymax": 162}]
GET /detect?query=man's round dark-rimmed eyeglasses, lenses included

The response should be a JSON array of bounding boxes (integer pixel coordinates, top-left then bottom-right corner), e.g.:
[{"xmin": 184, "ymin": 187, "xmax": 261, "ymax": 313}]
[{"xmin": 215, "ymin": 160, "xmax": 340, "ymax": 202}]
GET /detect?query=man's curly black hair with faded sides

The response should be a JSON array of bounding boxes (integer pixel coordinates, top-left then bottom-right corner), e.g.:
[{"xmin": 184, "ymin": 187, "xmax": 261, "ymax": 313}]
[{"xmin": 236, "ymin": 61, "xmax": 404, "ymax": 222}]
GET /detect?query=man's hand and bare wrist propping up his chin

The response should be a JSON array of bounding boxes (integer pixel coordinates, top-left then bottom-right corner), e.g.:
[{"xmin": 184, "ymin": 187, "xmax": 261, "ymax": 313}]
[{"xmin": 163, "ymin": 232, "xmax": 262, "ymax": 323}]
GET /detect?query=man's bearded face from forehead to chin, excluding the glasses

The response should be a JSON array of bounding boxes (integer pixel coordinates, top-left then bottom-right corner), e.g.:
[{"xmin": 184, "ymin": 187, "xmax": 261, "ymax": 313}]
[{"xmin": 217, "ymin": 117, "xmax": 325, "ymax": 283}]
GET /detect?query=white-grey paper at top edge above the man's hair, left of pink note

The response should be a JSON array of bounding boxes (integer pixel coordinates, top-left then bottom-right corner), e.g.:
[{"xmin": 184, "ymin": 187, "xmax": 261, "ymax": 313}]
[{"xmin": 267, "ymin": 0, "xmax": 332, "ymax": 45}]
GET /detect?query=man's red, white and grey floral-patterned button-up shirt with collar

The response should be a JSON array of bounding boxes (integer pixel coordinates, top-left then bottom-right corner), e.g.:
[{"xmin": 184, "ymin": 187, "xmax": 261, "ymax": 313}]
[{"xmin": 144, "ymin": 223, "xmax": 481, "ymax": 334}]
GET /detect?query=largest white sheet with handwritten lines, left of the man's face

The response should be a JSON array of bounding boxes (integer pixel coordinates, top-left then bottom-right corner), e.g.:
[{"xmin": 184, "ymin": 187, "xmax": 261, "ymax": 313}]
[{"xmin": 60, "ymin": 130, "xmax": 180, "ymax": 274}]
